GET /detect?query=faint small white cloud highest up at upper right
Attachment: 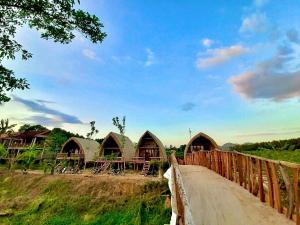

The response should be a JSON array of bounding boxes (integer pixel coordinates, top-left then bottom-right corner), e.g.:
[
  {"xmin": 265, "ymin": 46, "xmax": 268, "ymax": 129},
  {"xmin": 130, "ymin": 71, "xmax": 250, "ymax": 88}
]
[{"xmin": 240, "ymin": 13, "xmax": 268, "ymax": 33}]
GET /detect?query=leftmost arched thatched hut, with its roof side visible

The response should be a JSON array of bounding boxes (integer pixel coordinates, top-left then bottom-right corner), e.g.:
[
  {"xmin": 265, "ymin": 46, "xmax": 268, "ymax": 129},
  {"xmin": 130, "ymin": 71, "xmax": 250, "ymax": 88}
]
[{"xmin": 58, "ymin": 137, "xmax": 100, "ymax": 163}]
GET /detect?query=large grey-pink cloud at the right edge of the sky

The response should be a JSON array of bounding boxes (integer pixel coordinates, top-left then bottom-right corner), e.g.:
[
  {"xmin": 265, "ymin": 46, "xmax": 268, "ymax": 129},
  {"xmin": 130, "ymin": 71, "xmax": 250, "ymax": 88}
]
[{"xmin": 229, "ymin": 42, "xmax": 300, "ymax": 101}]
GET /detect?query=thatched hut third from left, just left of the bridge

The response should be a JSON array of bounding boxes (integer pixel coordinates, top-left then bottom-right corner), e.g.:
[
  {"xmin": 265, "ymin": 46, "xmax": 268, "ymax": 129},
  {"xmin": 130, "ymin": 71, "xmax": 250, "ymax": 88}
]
[{"xmin": 135, "ymin": 131, "xmax": 167, "ymax": 160}]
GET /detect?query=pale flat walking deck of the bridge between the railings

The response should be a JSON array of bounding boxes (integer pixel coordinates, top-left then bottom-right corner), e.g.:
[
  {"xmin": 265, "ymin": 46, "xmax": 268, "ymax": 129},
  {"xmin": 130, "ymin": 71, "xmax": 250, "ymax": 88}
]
[{"xmin": 179, "ymin": 165, "xmax": 295, "ymax": 225}]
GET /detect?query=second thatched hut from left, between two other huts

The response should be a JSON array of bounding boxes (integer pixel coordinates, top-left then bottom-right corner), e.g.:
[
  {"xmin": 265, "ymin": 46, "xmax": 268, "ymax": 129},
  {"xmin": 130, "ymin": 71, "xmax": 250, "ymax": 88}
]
[{"xmin": 99, "ymin": 132, "xmax": 134, "ymax": 161}]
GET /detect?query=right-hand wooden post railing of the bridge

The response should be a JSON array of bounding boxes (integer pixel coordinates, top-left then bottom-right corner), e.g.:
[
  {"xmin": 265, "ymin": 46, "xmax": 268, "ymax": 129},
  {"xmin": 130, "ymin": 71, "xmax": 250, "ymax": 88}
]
[{"xmin": 184, "ymin": 150, "xmax": 300, "ymax": 225}]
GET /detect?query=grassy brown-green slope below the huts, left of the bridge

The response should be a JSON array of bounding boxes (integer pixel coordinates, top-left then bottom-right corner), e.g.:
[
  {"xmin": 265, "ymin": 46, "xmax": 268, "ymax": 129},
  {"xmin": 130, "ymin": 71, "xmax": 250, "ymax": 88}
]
[{"xmin": 0, "ymin": 171, "xmax": 171, "ymax": 225}]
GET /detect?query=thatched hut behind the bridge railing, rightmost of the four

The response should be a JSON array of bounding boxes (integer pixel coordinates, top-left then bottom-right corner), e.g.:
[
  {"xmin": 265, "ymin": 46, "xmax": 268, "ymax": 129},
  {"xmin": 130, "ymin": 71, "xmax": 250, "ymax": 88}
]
[{"xmin": 184, "ymin": 132, "xmax": 218, "ymax": 155}]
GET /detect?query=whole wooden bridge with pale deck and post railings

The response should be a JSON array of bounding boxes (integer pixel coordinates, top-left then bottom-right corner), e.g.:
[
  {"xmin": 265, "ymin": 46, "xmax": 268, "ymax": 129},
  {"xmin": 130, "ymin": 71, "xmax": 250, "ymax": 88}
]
[{"xmin": 171, "ymin": 150, "xmax": 300, "ymax": 225}]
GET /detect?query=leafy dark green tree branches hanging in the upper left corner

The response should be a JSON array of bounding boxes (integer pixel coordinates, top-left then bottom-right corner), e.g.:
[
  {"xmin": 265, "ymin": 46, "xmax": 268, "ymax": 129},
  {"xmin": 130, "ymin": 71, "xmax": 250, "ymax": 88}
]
[{"xmin": 0, "ymin": 0, "xmax": 106, "ymax": 104}]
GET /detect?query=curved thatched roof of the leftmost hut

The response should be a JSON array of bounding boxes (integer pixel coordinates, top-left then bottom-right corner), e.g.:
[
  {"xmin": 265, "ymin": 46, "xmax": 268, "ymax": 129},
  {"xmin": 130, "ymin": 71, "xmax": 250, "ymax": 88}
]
[{"xmin": 61, "ymin": 137, "xmax": 100, "ymax": 162}]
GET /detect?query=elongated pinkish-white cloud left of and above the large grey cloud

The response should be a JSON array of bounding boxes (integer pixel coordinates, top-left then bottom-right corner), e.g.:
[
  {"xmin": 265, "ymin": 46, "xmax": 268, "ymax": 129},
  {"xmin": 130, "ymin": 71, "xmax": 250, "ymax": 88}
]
[{"xmin": 197, "ymin": 45, "xmax": 249, "ymax": 69}]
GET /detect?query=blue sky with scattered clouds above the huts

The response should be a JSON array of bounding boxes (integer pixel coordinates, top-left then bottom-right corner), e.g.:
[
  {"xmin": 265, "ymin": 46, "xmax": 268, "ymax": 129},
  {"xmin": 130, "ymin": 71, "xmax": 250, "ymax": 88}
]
[{"xmin": 0, "ymin": 0, "xmax": 300, "ymax": 146}]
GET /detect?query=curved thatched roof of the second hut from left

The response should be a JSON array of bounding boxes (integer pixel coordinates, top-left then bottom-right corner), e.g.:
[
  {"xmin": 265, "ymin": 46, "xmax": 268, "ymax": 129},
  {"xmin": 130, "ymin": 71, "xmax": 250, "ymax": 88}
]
[{"xmin": 100, "ymin": 132, "xmax": 134, "ymax": 160}]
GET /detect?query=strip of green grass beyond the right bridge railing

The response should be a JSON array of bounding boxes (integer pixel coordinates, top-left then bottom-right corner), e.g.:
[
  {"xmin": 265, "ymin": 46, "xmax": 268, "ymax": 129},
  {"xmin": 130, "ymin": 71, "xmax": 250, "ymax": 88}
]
[{"xmin": 244, "ymin": 149, "xmax": 300, "ymax": 163}]
